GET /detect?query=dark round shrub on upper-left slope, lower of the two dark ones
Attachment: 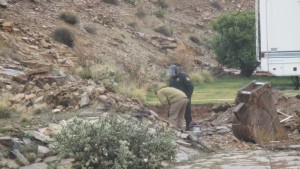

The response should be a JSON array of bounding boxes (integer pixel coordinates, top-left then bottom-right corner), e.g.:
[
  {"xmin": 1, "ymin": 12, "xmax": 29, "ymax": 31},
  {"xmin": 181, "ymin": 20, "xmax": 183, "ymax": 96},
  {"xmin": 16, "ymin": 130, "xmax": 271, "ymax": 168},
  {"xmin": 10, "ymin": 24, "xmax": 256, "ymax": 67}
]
[{"xmin": 52, "ymin": 27, "xmax": 75, "ymax": 48}]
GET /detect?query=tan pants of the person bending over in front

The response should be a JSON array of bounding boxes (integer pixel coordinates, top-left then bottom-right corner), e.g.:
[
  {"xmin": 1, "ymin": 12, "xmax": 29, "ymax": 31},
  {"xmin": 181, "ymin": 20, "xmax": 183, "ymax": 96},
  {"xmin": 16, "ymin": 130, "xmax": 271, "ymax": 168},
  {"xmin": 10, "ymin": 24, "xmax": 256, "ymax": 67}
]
[{"xmin": 168, "ymin": 98, "xmax": 189, "ymax": 129}]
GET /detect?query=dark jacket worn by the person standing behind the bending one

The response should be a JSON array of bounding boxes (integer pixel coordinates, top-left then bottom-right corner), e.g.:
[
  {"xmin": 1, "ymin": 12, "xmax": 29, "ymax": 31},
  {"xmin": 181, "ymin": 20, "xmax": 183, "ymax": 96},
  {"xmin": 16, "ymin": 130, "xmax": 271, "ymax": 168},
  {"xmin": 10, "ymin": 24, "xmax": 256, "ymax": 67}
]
[{"xmin": 169, "ymin": 72, "xmax": 194, "ymax": 99}]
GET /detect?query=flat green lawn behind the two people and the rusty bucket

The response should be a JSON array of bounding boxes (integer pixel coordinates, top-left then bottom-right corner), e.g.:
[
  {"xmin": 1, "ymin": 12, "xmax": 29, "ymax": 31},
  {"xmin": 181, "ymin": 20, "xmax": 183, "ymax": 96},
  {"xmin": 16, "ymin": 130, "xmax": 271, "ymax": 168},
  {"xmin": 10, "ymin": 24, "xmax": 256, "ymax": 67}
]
[{"xmin": 146, "ymin": 76, "xmax": 300, "ymax": 105}]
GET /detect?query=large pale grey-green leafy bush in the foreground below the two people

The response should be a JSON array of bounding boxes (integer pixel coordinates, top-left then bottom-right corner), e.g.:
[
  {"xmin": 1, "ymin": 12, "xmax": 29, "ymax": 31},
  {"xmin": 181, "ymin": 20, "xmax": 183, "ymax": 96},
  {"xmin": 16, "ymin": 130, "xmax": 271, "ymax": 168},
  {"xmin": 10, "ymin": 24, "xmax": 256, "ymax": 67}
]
[{"xmin": 51, "ymin": 117, "xmax": 177, "ymax": 169}]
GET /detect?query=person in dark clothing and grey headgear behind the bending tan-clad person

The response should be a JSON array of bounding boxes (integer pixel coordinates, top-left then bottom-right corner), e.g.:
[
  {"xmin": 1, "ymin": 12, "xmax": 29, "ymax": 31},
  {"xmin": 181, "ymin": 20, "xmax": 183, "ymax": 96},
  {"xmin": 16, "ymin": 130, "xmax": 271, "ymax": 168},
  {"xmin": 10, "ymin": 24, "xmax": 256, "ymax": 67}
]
[{"xmin": 167, "ymin": 65, "xmax": 194, "ymax": 131}]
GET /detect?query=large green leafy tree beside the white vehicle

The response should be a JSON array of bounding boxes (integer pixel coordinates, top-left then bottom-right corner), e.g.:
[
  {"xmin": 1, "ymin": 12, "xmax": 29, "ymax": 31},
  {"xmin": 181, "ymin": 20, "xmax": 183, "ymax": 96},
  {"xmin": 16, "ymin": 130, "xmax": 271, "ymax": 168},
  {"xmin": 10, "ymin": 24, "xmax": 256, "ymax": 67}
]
[{"xmin": 211, "ymin": 11, "xmax": 257, "ymax": 76}]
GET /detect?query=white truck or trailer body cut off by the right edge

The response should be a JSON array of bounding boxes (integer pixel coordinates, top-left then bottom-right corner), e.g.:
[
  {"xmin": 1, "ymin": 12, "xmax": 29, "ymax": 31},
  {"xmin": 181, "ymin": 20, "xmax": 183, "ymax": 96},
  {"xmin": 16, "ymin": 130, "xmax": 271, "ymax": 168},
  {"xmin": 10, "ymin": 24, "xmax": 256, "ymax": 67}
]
[{"xmin": 255, "ymin": 0, "xmax": 300, "ymax": 88}]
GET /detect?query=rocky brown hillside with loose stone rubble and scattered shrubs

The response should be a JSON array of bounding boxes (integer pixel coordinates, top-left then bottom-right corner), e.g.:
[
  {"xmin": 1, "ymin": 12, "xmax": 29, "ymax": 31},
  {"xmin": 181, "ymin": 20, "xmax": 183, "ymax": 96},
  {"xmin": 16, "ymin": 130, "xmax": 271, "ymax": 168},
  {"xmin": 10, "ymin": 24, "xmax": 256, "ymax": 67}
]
[{"xmin": 0, "ymin": 0, "xmax": 260, "ymax": 168}]
